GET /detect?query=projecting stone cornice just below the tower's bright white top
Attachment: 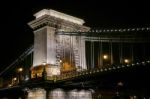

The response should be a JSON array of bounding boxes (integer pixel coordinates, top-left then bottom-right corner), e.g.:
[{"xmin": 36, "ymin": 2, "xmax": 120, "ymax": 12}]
[{"xmin": 28, "ymin": 15, "xmax": 90, "ymax": 31}]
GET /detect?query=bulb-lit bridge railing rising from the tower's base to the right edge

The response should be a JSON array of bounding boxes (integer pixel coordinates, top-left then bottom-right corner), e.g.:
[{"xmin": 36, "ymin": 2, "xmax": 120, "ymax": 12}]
[{"xmin": 27, "ymin": 61, "xmax": 150, "ymax": 82}]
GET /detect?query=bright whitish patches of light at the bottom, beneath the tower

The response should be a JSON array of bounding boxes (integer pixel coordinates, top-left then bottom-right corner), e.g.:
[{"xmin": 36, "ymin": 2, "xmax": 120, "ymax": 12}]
[{"xmin": 27, "ymin": 88, "xmax": 92, "ymax": 99}]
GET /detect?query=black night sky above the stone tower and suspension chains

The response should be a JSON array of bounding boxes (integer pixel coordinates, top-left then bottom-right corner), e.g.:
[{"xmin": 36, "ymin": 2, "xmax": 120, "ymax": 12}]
[{"xmin": 0, "ymin": 0, "xmax": 150, "ymax": 72}]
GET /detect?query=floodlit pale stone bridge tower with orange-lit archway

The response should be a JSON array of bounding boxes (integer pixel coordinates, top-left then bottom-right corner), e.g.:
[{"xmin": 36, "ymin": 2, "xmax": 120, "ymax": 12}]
[{"xmin": 29, "ymin": 9, "xmax": 89, "ymax": 78}]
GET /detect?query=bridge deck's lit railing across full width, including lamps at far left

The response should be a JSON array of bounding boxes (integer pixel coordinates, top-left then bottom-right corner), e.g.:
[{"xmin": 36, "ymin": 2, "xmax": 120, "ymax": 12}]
[{"xmin": 1, "ymin": 60, "xmax": 150, "ymax": 88}]
